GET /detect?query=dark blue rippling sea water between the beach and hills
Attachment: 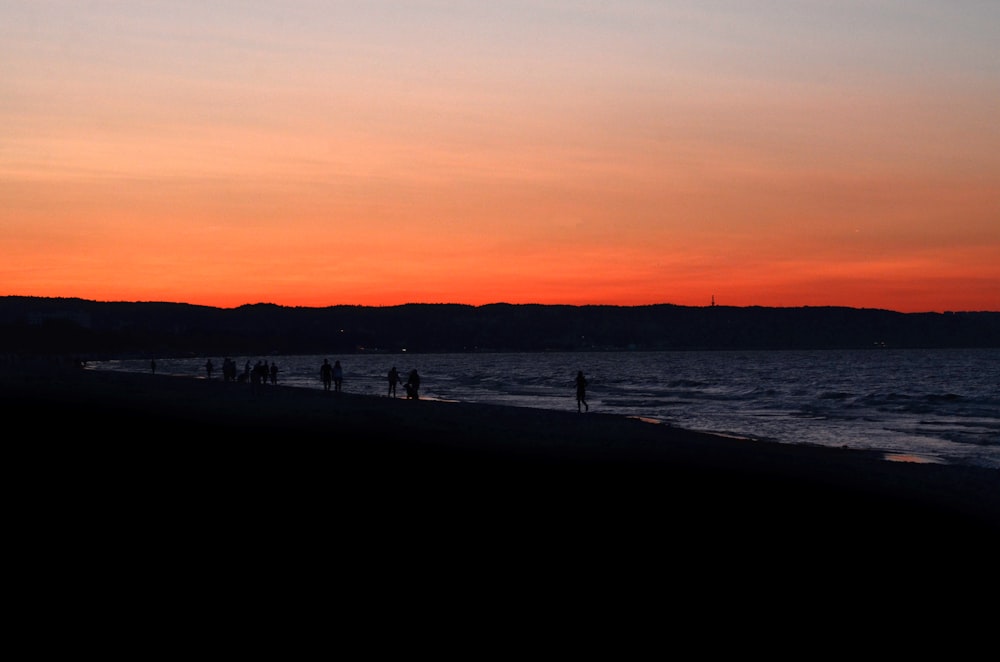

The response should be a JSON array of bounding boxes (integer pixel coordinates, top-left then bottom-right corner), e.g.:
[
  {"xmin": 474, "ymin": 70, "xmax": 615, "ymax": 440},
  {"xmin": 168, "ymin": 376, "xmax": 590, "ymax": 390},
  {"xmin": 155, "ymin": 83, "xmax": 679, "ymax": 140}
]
[{"xmin": 88, "ymin": 349, "xmax": 1000, "ymax": 469}]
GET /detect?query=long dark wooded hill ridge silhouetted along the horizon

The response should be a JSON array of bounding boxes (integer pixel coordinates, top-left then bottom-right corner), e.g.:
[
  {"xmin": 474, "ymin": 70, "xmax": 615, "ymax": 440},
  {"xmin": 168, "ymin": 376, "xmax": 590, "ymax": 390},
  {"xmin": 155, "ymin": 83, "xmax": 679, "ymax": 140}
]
[{"xmin": 0, "ymin": 296, "xmax": 1000, "ymax": 358}]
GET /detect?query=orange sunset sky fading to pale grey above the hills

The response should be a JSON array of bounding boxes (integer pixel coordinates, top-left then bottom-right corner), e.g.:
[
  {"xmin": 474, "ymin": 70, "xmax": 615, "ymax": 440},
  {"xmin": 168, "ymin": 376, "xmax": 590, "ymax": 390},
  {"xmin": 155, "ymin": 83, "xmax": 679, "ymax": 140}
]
[{"xmin": 0, "ymin": 0, "xmax": 1000, "ymax": 312}]
